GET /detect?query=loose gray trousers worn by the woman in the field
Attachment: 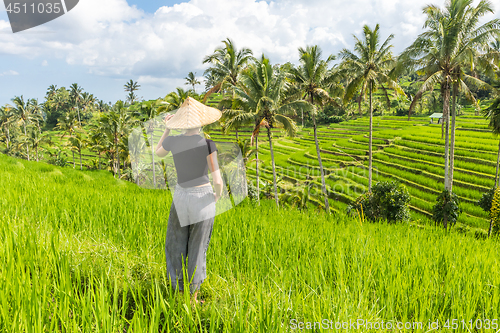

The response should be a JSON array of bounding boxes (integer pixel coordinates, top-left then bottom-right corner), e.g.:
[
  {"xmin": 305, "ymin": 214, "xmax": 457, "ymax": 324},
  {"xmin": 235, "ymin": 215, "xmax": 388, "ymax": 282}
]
[{"xmin": 165, "ymin": 186, "xmax": 214, "ymax": 293}]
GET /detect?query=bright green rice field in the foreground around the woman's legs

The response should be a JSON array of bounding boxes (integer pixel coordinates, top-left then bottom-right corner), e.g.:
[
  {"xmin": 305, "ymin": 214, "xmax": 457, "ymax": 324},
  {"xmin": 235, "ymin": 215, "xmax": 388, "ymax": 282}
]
[{"xmin": 0, "ymin": 156, "xmax": 500, "ymax": 333}]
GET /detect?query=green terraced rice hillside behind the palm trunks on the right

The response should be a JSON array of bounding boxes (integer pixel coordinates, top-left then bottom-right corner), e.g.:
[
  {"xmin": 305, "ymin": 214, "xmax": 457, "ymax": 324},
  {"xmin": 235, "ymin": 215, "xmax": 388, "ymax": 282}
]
[{"xmin": 248, "ymin": 117, "xmax": 498, "ymax": 228}]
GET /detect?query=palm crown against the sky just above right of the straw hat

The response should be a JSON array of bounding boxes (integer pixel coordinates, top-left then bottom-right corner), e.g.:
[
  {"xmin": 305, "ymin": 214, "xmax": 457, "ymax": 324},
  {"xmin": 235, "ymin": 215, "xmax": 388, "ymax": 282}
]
[{"xmin": 203, "ymin": 38, "xmax": 253, "ymax": 103}]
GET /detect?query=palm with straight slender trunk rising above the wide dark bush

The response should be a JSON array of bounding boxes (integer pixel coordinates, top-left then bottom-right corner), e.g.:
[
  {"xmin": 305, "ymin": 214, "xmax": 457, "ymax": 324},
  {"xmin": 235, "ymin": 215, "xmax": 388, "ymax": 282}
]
[{"xmin": 340, "ymin": 24, "xmax": 405, "ymax": 192}]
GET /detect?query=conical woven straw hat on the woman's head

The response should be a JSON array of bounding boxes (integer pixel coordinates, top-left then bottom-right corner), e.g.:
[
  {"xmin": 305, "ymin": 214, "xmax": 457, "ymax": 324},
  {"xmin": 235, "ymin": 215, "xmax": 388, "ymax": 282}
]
[{"xmin": 166, "ymin": 97, "xmax": 222, "ymax": 129}]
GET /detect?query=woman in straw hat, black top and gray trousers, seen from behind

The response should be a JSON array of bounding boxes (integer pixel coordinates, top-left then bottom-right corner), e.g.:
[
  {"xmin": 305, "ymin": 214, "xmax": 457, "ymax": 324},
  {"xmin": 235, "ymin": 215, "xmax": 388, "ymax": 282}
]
[{"xmin": 156, "ymin": 97, "xmax": 223, "ymax": 303}]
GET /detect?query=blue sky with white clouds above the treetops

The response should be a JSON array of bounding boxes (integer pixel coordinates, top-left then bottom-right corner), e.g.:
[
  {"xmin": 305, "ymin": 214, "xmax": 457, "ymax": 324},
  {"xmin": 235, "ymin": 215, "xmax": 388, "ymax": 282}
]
[{"xmin": 0, "ymin": 0, "xmax": 500, "ymax": 105}]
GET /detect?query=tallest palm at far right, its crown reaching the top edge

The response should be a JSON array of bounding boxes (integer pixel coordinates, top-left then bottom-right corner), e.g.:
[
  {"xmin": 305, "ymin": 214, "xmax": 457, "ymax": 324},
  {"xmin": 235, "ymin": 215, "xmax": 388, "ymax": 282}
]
[{"xmin": 399, "ymin": 0, "xmax": 500, "ymax": 198}]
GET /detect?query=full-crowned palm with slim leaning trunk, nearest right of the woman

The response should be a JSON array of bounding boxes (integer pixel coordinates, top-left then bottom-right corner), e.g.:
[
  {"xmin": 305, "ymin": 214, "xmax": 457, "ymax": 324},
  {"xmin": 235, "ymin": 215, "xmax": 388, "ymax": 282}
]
[{"xmin": 234, "ymin": 55, "xmax": 310, "ymax": 207}]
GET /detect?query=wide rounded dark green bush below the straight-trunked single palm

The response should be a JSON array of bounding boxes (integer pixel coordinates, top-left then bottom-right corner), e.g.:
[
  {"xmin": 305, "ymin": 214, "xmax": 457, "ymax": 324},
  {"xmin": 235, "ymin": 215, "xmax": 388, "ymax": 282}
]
[{"xmin": 347, "ymin": 181, "xmax": 410, "ymax": 223}]
